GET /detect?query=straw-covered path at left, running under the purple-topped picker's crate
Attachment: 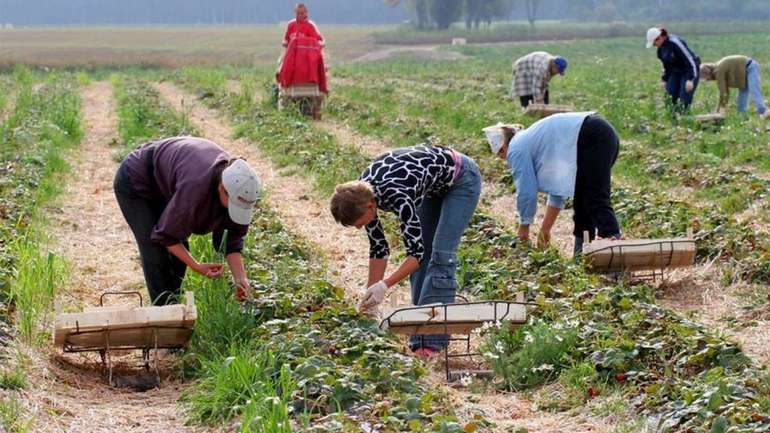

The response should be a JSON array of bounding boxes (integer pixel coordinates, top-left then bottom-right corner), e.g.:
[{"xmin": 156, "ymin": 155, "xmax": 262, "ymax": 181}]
[{"xmin": 27, "ymin": 82, "xmax": 200, "ymax": 433}]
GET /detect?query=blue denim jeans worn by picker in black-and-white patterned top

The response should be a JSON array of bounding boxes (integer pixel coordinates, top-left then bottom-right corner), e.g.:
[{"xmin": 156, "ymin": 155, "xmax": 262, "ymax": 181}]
[{"xmin": 409, "ymin": 155, "xmax": 481, "ymax": 350}]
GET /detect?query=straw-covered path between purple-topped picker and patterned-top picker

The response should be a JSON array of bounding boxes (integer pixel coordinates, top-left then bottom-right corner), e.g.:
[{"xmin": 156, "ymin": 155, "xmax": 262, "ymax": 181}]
[{"xmin": 156, "ymin": 82, "xmax": 378, "ymax": 298}]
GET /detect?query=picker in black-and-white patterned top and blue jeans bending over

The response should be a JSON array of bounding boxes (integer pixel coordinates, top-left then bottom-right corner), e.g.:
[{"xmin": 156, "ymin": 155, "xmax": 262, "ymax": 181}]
[{"xmin": 330, "ymin": 145, "xmax": 481, "ymax": 357}]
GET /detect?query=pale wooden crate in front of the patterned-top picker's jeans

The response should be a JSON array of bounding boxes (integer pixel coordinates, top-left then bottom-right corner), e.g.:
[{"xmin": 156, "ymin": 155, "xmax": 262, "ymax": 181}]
[{"xmin": 380, "ymin": 301, "xmax": 527, "ymax": 335}]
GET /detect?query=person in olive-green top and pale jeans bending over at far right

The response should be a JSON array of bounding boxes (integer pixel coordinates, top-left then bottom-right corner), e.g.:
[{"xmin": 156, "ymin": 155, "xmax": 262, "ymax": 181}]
[{"xmin": 700, "ymin": 56, "xmax": 770, "ymax": 119}]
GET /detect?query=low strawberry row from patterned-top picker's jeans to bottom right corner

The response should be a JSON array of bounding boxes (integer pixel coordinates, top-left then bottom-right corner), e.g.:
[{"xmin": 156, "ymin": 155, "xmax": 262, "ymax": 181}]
[{"xmin": 171, "ymin": 66, "xmax": 768, "ymax": 431}]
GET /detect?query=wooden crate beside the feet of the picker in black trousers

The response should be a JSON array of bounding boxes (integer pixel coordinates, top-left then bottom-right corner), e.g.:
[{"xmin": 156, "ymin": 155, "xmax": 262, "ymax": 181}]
[{"xmin": 583, "ymin": 238, "xmax": 696, "ymax": 272}]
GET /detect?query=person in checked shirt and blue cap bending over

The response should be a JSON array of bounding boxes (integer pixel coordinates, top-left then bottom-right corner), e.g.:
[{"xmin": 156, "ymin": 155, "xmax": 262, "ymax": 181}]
[{"xmin": 511, "ymin": 51, "xmax": 567, "ymax": 108}]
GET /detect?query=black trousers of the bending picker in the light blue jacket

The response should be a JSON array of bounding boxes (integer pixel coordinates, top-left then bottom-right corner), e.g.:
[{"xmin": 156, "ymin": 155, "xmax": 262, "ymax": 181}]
[{"xmin": 573, "ymin": 115, "xmax": 620, "ymax": 253}]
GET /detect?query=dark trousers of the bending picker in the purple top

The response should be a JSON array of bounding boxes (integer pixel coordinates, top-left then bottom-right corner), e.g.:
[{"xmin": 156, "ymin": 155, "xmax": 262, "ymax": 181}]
[{"xmin": 113, "ymin": 164, "xmax": 189, "ymax": 305}]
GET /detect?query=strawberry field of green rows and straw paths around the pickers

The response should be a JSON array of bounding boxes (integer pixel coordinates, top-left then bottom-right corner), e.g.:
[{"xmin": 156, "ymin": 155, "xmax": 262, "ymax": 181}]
[{"xmin": 0, "ymin": 27, "xmax": 770, "ymax": 433}]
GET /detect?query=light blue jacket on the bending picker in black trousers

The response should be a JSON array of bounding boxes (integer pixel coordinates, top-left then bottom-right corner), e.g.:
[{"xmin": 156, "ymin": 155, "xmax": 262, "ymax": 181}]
[{"xmin": 507, "ymin": 111, "xmax": 594, "ymax": 225}]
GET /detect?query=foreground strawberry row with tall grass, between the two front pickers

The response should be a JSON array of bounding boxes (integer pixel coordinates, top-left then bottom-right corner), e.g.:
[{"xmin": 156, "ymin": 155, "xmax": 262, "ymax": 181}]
[{"xmin": 114, "ymin": 74, "xmax": 461, "ymax": 433}]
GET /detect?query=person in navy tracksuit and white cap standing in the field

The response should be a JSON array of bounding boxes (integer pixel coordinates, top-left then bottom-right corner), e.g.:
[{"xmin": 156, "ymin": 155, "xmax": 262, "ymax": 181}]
[{"xmin": 647, "ymin": 27, "xmax": 700, "ymax": 112}]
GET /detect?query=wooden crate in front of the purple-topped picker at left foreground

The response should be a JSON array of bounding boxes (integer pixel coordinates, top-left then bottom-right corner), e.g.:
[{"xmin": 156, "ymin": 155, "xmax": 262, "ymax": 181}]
[{"xmin": 53, "ymin": 292, "xmax": 198, "ymax": 352}]
